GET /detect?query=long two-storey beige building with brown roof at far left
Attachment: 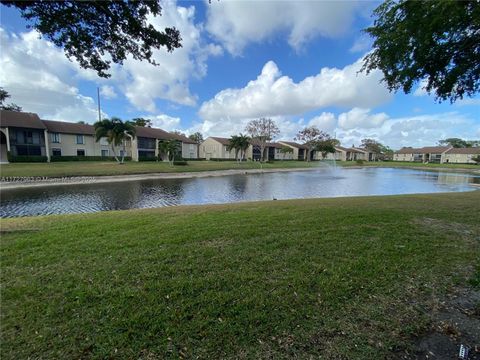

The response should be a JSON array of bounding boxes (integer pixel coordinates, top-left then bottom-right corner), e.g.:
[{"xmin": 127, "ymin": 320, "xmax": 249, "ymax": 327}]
[{"xmin": 0, "ymin": 110, "xmax": 198, "ymax": 162}]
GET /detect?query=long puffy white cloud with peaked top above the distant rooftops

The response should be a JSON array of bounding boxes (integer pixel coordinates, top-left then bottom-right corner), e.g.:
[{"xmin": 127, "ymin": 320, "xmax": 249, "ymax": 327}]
[{"xmin": 199, "ymin": 59, "xmax": 391, "ymax": 121}]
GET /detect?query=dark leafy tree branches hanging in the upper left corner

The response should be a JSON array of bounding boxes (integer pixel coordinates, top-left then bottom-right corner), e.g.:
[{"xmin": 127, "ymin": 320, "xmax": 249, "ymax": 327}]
[{"xmin": 0, "ymin": 0, "xmax": 182, "ymax": 78}]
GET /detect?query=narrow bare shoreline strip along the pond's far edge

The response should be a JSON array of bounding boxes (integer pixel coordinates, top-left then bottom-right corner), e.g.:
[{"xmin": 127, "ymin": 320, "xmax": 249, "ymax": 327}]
[{"xmin": 0, "ymin": 165, "xmax": 480, "ymax": 191}]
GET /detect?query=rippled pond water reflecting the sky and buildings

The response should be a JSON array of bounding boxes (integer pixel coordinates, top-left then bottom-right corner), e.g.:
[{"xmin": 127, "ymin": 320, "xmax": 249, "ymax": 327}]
[{"xmin": 0, "ymin": 168, "xmax": 480, "ymax": 217}]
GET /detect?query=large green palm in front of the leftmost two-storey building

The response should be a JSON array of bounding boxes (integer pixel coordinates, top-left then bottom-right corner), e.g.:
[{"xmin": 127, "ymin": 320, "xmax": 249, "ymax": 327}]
[{"xmin": 93, "ymin": 117, "xmax": 135, "ymax": 164}]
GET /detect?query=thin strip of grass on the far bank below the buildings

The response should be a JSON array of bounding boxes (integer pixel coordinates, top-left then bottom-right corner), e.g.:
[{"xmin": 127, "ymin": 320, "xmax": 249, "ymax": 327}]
[{"xmin": 0, "ymin": 161, "xmax": 480, "ymax": 177}]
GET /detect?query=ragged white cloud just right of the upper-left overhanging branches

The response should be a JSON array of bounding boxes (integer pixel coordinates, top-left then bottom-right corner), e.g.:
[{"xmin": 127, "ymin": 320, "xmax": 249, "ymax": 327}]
[{"xmin": 121, "ymin": 1, "xmax": 222, "ymax": 112}]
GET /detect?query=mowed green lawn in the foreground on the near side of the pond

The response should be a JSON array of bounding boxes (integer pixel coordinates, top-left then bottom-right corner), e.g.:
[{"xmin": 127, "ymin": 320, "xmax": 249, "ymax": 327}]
[{"xmin": 0, "ymin": 191, "xmax": 480, "ymax": 359}]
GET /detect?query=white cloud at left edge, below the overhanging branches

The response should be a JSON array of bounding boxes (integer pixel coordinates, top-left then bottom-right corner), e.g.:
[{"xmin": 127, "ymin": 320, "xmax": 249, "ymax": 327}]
[{"xmin": 0, "ymin": 28, "xmax": 104, "ymax": 122}]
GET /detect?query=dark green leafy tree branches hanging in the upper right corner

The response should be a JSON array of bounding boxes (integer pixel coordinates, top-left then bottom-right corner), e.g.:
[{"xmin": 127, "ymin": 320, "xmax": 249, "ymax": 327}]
[{"xmin": 362, "ymin": 0, "xmax": 480, "ymax": 102}]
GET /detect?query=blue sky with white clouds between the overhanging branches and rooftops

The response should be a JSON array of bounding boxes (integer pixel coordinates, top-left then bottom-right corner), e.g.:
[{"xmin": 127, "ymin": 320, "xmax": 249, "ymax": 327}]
[{"xmin": 0, "ymin": 0, "xmax": 480, "ymax": 149}]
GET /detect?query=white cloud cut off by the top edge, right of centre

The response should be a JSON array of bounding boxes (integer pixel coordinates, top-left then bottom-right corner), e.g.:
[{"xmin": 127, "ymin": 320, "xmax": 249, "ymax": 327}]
[{"xmin": 206, "ymin": 0, "xmax": 361, "ymax": 55}]
